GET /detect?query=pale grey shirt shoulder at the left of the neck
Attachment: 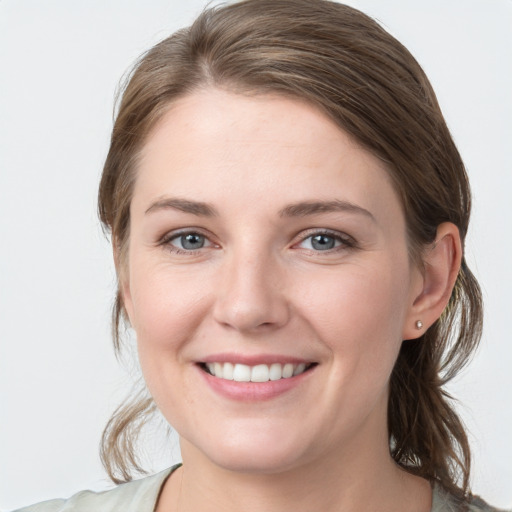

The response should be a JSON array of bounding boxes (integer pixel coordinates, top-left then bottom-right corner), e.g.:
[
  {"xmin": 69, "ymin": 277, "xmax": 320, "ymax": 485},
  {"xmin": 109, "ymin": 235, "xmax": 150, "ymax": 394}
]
[{"xmin": 15, "ymin": 466, "xmax": 176, "ymax": 512}]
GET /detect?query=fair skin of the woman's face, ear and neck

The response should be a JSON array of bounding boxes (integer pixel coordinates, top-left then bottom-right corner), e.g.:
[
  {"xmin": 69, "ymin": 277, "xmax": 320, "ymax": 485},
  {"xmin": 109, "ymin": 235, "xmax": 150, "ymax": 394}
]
[{"xmin": 120, "ymin": 89, "xmax": 460, "ymax": 512}]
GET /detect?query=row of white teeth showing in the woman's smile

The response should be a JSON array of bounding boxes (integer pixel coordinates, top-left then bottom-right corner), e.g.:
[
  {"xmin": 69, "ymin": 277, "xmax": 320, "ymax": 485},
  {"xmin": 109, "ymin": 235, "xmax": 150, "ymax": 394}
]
[{"xmin": 201, "ymin": 362, "xmax": 316, "ymax": 382}]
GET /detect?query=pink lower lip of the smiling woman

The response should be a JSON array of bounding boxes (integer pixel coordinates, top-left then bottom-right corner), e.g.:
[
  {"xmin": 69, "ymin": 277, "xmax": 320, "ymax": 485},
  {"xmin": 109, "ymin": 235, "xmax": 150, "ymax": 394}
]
[{"xmin": 198, "ymin": 367, "xmax": 315, "ymax": 402}]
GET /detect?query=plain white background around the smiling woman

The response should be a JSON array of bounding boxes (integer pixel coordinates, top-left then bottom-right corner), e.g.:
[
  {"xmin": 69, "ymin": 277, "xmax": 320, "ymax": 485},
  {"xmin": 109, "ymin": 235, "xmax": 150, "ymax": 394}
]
[{"xmin": 0, "ymin": 0, "xmax": 512, "ymax": 510}]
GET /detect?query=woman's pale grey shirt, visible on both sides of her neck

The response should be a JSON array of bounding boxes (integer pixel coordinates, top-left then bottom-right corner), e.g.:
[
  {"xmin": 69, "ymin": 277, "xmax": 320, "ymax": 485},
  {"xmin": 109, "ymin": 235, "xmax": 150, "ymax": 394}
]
[{"xmin": 15, "ymin": 465, "xmax": 512, "ymax": 512}]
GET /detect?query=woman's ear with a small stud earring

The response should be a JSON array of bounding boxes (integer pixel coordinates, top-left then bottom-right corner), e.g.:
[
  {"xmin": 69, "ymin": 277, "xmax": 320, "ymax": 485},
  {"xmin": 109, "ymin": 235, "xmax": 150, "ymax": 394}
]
[{"xmin": 402, "ymin": 222, "xmax": 462, "ymax": 340}]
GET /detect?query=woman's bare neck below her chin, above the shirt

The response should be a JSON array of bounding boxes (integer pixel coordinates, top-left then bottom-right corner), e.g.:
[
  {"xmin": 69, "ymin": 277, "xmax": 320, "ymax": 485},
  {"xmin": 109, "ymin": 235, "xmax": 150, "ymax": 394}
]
[{"xmin": 157, "ymin": 432, "xmax": 431, "ymax": 512}]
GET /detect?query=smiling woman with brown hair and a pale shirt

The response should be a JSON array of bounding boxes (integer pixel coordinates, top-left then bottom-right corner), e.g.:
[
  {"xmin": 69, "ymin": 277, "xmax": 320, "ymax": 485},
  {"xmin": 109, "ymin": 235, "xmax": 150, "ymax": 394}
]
[{"xmin": 12, "ymin": 0, "xmax": 508, "ymax": 511}]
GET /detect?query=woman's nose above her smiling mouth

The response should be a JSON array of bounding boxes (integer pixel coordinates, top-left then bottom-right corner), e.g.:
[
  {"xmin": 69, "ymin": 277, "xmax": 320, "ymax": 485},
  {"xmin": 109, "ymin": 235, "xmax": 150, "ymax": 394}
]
[{"xmin": 213, "ymin": 248, "xmax": 290, "ymax": 333}]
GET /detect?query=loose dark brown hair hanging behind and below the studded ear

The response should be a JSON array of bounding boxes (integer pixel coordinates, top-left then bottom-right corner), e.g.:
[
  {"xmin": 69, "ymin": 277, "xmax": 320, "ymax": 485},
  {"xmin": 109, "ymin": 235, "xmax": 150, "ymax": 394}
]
[{"xmin": 388, "ymin": 263, "xmax": 482, "ymax": 500}]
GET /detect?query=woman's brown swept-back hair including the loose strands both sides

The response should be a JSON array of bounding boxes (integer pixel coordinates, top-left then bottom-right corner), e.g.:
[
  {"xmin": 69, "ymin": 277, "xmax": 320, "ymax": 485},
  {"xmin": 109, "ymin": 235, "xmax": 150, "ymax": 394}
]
[{"xmin": 99, "ymin": 0, "xmax": 482, "ymax": 498}]
